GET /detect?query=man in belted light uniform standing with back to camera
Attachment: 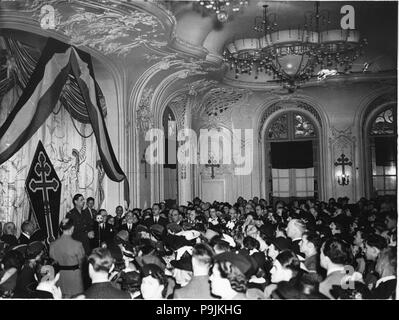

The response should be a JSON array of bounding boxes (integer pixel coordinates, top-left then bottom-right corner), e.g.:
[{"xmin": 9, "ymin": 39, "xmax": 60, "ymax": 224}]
[{"xmin": 50, "ymin": 218, "xmax": 85, "ymax": 298}]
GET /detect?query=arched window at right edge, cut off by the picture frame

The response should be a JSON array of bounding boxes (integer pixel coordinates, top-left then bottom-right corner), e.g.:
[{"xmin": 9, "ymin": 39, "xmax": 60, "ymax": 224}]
[{"xmin": 367, "ymin": 105, "xmax": 397, "ymax": 196}]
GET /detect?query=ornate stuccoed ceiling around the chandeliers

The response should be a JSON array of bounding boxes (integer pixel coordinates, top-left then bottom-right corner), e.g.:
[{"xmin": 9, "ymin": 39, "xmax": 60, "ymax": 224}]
[{"xmin": 0, "ymin": 0, "xmax": 397, "ymax": 88}]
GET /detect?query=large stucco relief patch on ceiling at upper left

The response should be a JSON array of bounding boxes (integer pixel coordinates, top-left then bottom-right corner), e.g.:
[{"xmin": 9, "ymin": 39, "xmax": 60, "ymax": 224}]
[{"xmin": 25, "ymin": 0, "xmax": 167, "ymax": 56}]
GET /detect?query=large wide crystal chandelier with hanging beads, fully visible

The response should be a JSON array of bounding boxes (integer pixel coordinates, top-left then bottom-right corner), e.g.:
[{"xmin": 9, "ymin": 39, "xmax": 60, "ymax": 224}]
[{"xmin": 223, "ymin": 2, "xmax": 366, "ymax": 90}]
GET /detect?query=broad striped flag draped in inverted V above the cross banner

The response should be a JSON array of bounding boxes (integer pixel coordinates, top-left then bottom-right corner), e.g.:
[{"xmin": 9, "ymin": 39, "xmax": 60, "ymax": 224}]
[{"xmin": 0, "ymin": 39, "xmax": 129, "ymax": 204}]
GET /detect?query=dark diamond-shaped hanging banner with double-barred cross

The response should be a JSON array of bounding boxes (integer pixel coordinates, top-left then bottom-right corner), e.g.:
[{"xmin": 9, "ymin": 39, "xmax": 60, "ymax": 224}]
[{"xmin": 25, "ymin": 141, "xmax": 61, "ymax": 244}]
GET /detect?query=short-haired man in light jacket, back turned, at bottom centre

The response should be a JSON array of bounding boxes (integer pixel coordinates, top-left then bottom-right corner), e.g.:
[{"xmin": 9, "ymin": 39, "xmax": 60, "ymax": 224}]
[{"xmin": 174, "ymin": 243, "xmax": 216, "ymax": 300}]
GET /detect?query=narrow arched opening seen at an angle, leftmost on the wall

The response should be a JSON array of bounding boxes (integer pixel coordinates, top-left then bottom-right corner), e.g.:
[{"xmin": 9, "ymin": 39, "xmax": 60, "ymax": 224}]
[{"xmin": 162, "ymin": 107, "xmax": 179, "ymax": 206}]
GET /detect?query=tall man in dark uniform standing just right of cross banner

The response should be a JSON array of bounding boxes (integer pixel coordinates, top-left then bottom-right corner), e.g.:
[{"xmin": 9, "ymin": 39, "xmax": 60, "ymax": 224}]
[{"xmin": 66, "ymin": 193, "xmax": 94, "ymax": 256}]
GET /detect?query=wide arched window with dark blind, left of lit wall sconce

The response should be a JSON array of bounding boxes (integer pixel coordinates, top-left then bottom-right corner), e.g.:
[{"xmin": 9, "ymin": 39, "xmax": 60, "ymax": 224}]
[{"xmin": 265, "ymin": 111, "xmax": 320, "ymax": 203}]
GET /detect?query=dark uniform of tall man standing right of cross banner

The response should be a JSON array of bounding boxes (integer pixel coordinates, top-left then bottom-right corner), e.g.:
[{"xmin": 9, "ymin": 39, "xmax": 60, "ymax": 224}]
[{"xmin": 66, "ymin": 208, "xmax": 93, "ymax": 255}]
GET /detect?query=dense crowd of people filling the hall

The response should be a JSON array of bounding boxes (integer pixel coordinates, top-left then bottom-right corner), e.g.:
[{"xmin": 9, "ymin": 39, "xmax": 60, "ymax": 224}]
[{"xmin": 0, "ymin": 194, "xmax": 397, "ymax": 300}]
